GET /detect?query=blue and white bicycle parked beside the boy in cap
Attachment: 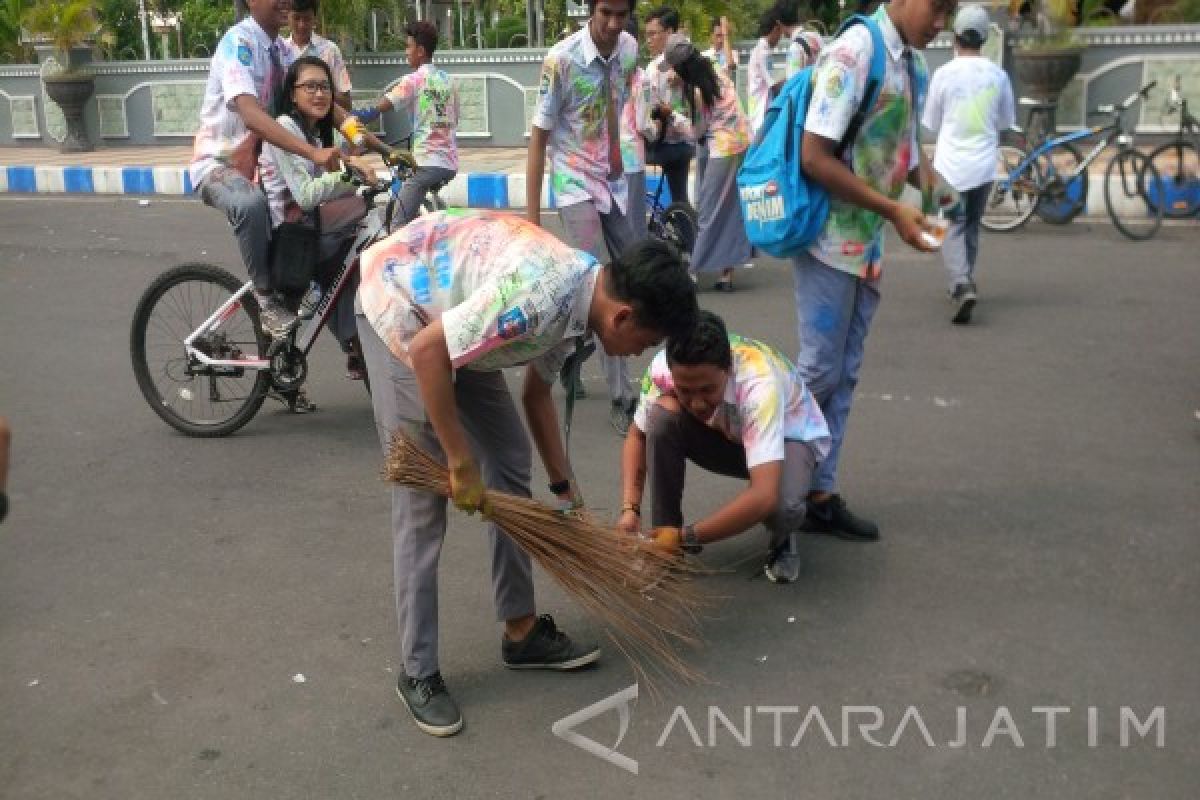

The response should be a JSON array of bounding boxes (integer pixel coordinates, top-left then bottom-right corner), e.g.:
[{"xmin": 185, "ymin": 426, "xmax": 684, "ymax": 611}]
[{"xmin": 983, "ymin": 82, "xmax": 1164, "ymax": 241}]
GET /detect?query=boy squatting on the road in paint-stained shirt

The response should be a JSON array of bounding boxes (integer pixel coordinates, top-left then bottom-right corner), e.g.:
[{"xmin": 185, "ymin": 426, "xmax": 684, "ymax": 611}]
[{"xmin": 617, "ymin": 311, "xmax": 829, "ymax": 583}]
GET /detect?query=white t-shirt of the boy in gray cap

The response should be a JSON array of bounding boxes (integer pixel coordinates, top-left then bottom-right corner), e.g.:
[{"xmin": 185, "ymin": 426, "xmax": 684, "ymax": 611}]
[{"xmin": 922, "ymin": 55, "xmax": 1016, "ymax": 192}]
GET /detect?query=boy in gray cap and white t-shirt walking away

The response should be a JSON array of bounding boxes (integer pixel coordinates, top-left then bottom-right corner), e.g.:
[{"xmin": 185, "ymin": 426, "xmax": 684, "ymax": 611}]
[{"xmin": 922, "ymin": 6, "xmax": 1016, "ymax": 325}]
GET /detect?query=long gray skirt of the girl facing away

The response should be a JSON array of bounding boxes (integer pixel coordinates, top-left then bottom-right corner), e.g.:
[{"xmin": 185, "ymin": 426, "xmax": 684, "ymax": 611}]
[{"xmin": 691, "ymin": 154, "xmax": 754, "ymax": 272}]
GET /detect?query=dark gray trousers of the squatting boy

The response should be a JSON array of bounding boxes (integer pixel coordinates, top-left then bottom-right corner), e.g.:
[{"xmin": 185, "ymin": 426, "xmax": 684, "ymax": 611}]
[{"xmin": 646, "ymin": 404, "xmax": 816, "ymax": 541}]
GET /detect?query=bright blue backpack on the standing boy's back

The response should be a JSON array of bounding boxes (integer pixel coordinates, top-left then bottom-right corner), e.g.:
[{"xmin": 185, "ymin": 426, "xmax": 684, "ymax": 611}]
[{"xmin": 738, "ymin": 14, "xmax": 887, "ymax": 258}]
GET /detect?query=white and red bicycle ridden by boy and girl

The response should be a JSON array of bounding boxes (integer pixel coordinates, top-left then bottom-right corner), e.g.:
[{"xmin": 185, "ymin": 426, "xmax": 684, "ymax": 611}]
[{"xmin": 130, "ymin": 154, "xmax": 415, "ymax": 438}]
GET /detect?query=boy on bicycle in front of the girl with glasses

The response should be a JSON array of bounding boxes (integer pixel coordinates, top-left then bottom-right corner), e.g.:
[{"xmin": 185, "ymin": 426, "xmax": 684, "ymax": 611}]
[{"xmin": 188, "ymin": 0, "xmax": 341, "ymax": 337}]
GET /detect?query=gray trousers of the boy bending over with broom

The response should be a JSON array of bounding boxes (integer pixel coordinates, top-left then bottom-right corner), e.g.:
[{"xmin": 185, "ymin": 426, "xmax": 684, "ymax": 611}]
[{"xmin": 356, "ymin": 314, "xmax": 534, "ymax": 678}]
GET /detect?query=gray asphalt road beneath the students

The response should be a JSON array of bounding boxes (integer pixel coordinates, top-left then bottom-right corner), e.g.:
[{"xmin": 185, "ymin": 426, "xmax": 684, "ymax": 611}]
[{"xmin": 0, "ymin": 197, "xmax": 1200, "ymax": 800}]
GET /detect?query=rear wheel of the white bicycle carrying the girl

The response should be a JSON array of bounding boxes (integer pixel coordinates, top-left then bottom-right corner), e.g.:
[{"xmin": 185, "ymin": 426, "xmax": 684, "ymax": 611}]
[{"xmin": 130, "ymin": 264, "xmax": 271, "ymax": 438}]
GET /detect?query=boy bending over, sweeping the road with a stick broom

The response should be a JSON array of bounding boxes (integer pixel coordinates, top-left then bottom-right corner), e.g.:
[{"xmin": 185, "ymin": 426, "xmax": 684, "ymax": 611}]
[{"xmin": 356, "ymin": 211, "xmax": 697, "ymax": 736}]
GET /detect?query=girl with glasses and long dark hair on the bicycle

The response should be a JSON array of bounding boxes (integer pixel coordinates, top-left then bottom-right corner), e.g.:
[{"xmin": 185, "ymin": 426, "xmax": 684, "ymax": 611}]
[{"xmin": 259, "ymin": 56, "xmax": 373, "ymax": 380}]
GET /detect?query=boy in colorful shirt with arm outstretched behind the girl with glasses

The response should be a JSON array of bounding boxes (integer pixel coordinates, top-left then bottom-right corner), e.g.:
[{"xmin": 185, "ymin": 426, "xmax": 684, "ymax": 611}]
[{"xmin": 354, "ymin": 22, "xmax": 458, "ymax": 224}]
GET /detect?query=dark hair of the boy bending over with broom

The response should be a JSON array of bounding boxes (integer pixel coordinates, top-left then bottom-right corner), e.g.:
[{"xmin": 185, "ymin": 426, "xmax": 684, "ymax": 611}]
[{"xmin": 605, "ymin": 239, "xmax": 698, "ymax": 337}]
